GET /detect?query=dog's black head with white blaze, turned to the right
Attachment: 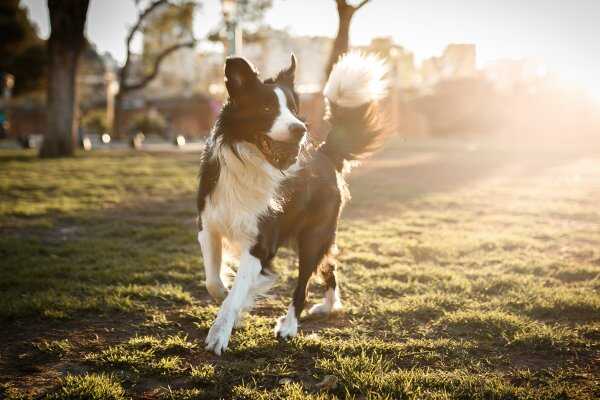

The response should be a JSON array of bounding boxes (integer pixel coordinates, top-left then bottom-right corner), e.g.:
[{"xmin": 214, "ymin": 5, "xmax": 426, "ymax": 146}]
[{"xmin": 220, "ymin": 55, "xmax": 306, "ymax": 169}]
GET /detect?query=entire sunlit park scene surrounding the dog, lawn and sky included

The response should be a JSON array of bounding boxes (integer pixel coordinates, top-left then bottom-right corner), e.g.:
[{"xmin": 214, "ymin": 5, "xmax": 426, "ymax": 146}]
[{"xmin": 0, "ymin": 0, "xmax": 600, "ymax": 400}]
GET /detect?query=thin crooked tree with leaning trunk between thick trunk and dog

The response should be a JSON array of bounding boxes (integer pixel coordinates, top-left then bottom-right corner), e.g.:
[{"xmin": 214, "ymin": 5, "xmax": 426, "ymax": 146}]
[{"xmin": 111, "ymin": 0, "xmax": 196, "ymax": 137}]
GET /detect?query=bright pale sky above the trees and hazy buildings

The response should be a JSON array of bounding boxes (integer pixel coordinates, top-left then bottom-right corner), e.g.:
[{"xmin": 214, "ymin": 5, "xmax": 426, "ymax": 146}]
[{"xmin": 23, "ymin": 0, "xmax": 600, "ymax": 98}]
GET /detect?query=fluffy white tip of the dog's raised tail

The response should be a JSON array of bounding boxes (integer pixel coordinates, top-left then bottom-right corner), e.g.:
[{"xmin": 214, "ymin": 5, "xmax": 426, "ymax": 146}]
[{"xmin": 323, "ymin": 51, "xmax": 388, "ymax": 107}]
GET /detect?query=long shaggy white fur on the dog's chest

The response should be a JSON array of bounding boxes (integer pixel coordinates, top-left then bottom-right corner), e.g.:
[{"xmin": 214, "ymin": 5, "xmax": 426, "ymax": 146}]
[{"xmin": 201, "ymin": 139, "xmax": 284, "ymax": 250}]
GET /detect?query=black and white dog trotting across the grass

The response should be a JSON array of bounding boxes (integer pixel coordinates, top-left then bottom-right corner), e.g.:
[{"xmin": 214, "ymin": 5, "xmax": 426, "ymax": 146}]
[{"xmin": 198, "ymin": 53, "xmax": 386, "ymax": 354}]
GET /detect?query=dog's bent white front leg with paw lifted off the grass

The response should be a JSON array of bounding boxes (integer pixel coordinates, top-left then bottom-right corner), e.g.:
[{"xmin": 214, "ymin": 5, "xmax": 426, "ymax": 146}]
[{"xmin": 198, "ymin": 227, "xmax": 227, "ymax": 302}]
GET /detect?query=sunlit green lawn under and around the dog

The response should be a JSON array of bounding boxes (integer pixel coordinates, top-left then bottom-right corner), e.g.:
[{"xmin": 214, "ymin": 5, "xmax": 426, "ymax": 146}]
[{"xmin": 0, "ymin": 140, "xmax": 600, "ymax": 399}]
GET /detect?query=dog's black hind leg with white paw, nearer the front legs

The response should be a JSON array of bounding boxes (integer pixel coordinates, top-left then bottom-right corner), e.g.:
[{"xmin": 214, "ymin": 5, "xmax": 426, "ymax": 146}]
[{"xmin": 275, "ymin": 226, "xmax": 335, "ymax": 338}]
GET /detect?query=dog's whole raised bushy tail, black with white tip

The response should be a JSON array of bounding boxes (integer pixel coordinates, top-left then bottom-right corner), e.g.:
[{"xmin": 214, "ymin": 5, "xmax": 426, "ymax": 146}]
[{"xmin": 321, "ymin": 52, "xmax": 390, "ymax": 171}]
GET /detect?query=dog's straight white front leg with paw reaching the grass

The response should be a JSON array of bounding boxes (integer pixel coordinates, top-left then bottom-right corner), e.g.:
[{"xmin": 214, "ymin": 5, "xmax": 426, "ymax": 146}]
[{"xmin": 205, "ymin": 250, "xmax": 261, "ymax": 355}]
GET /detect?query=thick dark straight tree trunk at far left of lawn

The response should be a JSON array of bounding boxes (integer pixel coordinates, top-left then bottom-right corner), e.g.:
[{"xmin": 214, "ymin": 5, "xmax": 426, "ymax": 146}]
[{"xmin": 40, "ymin": 0, "xmax": 89, "ymax": 157}]
